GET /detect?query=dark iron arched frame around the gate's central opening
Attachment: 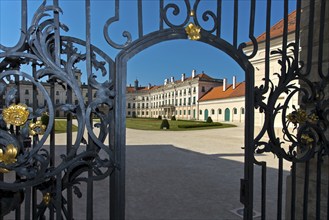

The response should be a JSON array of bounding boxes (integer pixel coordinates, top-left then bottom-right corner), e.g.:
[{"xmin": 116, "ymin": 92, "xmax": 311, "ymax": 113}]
[{"xmin": 114, "ymin": 27, "xmax": 254, "ymax": 218}]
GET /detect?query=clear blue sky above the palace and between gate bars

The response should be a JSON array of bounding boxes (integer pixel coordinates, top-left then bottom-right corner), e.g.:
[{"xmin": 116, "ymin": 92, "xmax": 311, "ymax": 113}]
[{"xmin": 0, "ymin": 0, "xmax": 296, "ymax": 85}]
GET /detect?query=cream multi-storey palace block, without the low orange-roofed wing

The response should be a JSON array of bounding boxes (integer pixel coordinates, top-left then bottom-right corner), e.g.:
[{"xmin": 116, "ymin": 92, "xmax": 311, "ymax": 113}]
[{"xmin": 126, "ymin": 70, "xmax": 223, "ymax": 120}]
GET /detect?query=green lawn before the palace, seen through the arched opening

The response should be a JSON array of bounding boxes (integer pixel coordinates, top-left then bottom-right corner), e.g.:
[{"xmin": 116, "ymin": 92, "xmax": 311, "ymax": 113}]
[{"xmin": 126, "ymin": 118, "xmax": 236, "ymax": 131}]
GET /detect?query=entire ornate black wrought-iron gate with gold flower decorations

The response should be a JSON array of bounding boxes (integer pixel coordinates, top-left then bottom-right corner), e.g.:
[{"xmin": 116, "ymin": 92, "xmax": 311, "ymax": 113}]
[{"xmin": 0, "ymin": 0, "xmax": 329, "ymax": 219}]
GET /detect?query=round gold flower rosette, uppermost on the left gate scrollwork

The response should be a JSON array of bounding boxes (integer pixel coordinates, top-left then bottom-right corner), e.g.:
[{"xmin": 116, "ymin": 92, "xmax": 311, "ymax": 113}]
[{"xmin": 2, "ymin": 104, "xmax": 30, "ymax": 126}]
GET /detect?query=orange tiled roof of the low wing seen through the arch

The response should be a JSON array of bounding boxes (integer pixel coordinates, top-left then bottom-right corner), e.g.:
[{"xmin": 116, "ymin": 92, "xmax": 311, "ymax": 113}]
[{"xmin": 199, "ymin": 82, "xmax": 246, "ymax": 101}]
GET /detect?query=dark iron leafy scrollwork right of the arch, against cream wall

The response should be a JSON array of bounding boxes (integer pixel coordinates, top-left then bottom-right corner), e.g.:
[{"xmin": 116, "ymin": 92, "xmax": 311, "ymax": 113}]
[{"xmin": 255, "ymin": 43, "xmax": 329, "ymax": 162}]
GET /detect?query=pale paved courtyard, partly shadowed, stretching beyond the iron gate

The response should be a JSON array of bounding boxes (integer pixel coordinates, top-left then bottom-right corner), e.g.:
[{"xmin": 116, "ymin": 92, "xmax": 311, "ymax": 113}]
[{"xmin": 5, "ymin": 124, "xmax": 289, "ymax": 220}]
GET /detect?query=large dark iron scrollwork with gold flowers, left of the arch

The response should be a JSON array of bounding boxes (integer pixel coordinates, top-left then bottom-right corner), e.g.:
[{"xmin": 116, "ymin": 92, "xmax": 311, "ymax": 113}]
[{"xmin": 0, "ymin": 1, "xmax": 115, "ymax": 218}]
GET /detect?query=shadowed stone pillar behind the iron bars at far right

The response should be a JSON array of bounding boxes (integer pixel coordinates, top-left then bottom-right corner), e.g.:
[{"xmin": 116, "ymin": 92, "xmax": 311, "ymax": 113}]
[{"xmin": 286, "ymin": 0, "xmax": 329, "ymax": 219}]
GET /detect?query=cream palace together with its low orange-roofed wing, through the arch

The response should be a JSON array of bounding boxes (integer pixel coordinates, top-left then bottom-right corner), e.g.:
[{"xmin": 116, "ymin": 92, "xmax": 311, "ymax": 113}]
[{"xmin": 126, "ymin": 70, "xmax": 245, "ymax": 122}]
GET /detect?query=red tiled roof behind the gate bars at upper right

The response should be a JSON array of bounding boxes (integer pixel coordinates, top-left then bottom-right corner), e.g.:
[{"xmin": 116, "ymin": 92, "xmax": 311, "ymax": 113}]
[{"xmin": 247, "ymin": 10, "xmax": 296, "ymax": 45}]
